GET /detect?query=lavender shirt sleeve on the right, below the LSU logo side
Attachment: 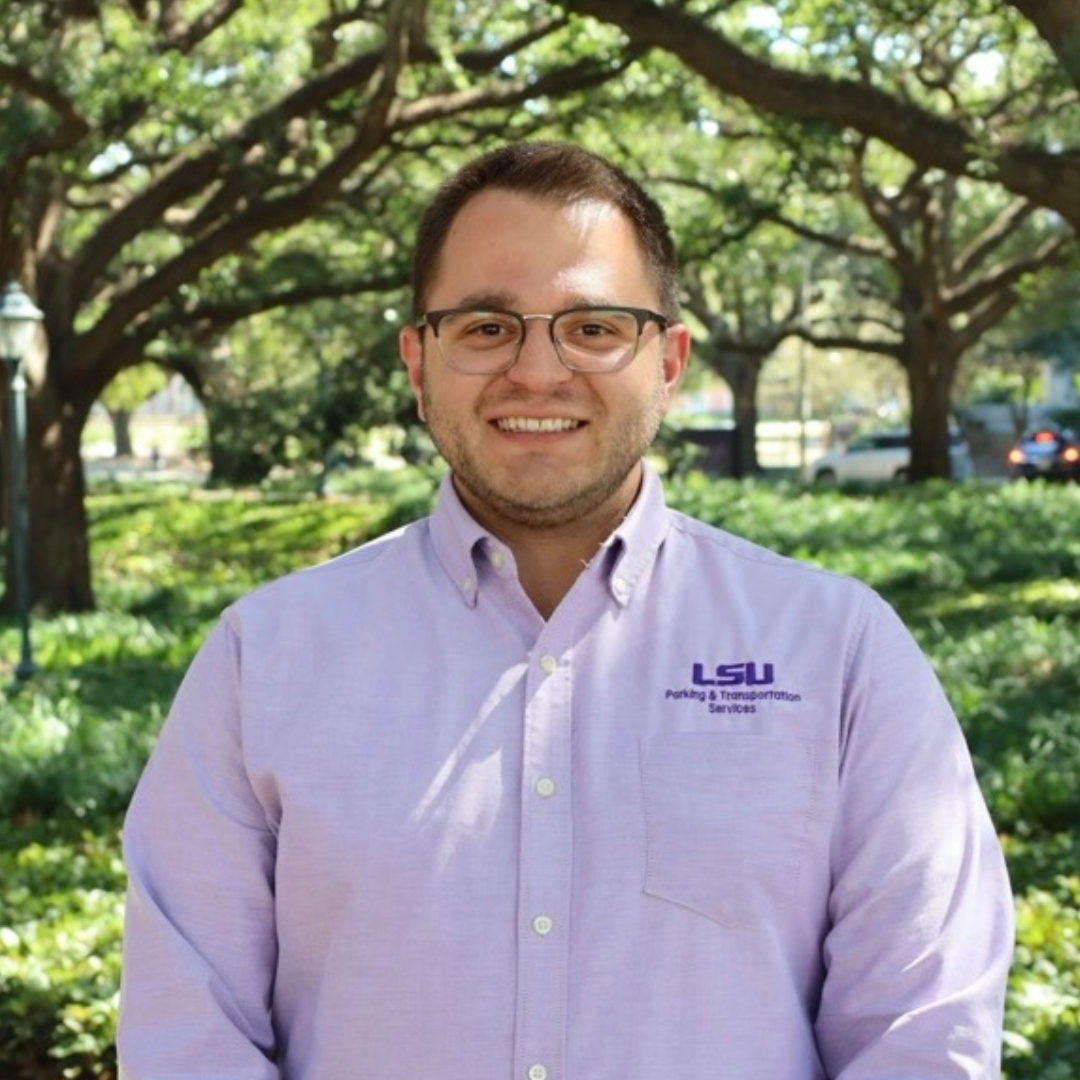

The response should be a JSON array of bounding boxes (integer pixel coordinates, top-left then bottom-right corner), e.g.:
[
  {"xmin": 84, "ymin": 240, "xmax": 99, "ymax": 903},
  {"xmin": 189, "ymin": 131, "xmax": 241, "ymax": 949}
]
[{"xmin": 816, "ymin": 602, "xmax": 1013, "ymax": 1080}]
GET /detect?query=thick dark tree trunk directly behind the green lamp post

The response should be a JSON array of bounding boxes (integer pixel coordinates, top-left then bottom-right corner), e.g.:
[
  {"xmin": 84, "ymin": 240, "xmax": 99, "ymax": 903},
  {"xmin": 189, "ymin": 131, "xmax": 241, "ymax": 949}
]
[{"xmin": 3, "ymin": 388, "xmax": 94, "ymax": 611}]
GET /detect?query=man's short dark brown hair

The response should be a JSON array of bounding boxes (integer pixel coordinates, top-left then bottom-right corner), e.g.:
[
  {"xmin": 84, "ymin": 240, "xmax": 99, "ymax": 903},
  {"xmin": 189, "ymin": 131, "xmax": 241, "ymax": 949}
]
[{"xmin": 413, "ymin": 141, "xmax": 678, "ymax": 320}]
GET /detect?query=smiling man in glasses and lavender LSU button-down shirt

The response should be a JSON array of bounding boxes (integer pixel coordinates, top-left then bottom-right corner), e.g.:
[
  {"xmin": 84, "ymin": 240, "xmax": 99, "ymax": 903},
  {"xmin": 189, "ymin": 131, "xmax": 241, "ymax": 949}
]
[{"xmin": 119, "ymin": 143, "xmax": 1012, "ymax": 1080}]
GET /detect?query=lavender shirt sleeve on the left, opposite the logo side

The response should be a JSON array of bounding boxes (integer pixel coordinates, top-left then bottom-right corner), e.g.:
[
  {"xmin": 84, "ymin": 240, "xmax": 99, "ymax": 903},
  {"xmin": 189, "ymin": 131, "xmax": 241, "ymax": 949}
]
[{"xmin": 117, "ymin": 621, "xmax": 279, "ymax": 1080}]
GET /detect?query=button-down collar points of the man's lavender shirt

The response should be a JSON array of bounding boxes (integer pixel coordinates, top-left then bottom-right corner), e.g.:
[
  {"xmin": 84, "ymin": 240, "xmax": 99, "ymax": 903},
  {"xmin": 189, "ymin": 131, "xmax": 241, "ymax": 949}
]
[{"xmin": 431, "ymin": 462, "xmax": 670, "ymax": 607}]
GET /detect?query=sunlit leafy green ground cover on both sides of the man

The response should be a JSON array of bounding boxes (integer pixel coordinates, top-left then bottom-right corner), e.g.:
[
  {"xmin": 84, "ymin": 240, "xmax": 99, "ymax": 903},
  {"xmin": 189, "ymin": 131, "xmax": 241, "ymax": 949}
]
[{"xmin": 0, "ymin": 472, "xmax": 1080, "ymax": 1080}]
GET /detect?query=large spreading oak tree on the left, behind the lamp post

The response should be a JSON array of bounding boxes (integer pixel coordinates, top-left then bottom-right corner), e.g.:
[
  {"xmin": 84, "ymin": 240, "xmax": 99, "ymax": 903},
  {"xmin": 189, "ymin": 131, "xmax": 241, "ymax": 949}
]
[{"xmin": 0, "ymin": 0, "xmax": 625, "ymax": 610}]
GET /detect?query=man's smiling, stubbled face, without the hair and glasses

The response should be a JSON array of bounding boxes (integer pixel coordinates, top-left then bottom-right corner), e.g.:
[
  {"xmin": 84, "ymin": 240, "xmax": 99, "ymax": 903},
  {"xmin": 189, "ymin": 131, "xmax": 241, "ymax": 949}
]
[{"xmin": 401, "ymin": 189, "xmax": 688, "ymax": 531}]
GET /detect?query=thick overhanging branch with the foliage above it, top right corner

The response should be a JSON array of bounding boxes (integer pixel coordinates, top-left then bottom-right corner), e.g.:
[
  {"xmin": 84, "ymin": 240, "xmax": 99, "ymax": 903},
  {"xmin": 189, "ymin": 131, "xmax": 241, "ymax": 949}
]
[{"xmin": 561, "ymin": 0, "xmax": 1080, "ymax": 229}]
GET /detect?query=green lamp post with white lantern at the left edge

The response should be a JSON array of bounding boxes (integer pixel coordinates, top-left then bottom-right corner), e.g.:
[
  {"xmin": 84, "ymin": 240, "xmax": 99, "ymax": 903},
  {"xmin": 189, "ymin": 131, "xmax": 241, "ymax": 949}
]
[{"xmin": 0, "ymin": 281, "xmax": 44, "ymax": 680}]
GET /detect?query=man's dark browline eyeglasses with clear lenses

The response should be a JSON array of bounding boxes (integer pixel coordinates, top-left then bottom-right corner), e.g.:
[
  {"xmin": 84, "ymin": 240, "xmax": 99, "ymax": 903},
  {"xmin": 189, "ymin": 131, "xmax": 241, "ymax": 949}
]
[{"xmin": 416, "ymin": 308, "xmax": 669, "ymax": 375}]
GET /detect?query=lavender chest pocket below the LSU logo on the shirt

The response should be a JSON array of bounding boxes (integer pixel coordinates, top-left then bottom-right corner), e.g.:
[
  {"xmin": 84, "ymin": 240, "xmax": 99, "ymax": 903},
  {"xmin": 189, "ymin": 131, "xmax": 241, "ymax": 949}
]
[{"xmin": 642, "ymin": 732, "xmax": 816, "ymax": 928}]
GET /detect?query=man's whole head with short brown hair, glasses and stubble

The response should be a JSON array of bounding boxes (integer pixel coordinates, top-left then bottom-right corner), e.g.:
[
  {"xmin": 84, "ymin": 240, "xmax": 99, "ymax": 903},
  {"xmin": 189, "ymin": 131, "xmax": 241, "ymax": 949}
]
[{"xmin": 401, "ymin": 144, "xmax": 689, "ymax": 537}]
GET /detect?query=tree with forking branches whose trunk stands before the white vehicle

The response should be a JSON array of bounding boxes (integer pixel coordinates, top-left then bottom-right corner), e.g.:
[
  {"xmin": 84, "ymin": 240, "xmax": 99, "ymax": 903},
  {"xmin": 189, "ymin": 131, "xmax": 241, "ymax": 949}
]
[{"xmin": 770, "ymin": 144, "xmax": 1075, "ymax": 481}]
